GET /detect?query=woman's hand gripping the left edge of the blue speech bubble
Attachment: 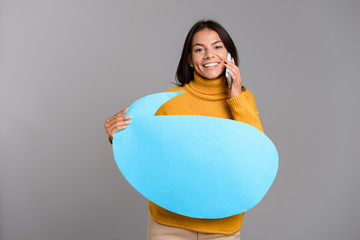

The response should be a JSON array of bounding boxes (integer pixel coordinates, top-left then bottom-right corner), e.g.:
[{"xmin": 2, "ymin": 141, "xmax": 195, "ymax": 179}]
[{"xmin": 104, "ymin": 108, "xmax": 132, "ymax": 141}]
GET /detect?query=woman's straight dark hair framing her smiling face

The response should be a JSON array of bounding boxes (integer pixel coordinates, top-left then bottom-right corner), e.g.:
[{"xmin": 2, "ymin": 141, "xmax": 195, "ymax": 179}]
[{"xmin": 176, "ymin": 20, "xmax": 239, "ymax": 86}]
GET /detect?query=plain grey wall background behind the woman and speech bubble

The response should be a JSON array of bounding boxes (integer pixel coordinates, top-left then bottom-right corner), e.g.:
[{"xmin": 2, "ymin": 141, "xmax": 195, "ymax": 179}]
[{"xmin": 0, "ymin": 0, "xmax": 360, "ymax": 240}]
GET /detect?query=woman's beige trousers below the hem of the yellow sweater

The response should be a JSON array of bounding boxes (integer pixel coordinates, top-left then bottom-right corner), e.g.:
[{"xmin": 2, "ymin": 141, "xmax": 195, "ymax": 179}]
[{"xmin": 147, "ymin": 214, "xmax": 240, "ymax": 240}]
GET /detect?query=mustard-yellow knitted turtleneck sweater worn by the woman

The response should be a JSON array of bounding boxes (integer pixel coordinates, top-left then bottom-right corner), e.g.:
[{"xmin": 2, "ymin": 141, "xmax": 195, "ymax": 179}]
[{"xmin": 149, "ymin": 72, "xmax": 263, "ymax": 234}]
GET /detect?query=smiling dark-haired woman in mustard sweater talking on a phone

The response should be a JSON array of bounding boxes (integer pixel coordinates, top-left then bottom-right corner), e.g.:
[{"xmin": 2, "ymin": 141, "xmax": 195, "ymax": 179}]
[{"xmin": 105, "ymin": 20, "xmax": 263, "ymax": 240}]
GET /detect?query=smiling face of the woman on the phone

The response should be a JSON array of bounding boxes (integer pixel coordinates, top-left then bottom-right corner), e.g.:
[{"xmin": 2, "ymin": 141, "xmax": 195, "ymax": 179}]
[{"xmin": 188, "ymin": 28, "xmax": 227, "ymax": 79}]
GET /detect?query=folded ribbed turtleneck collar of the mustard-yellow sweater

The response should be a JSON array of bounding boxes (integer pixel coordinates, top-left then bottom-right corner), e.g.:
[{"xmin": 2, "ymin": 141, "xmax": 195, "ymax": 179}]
[{"xmin": 185, "ymin": 71, "xmax": 229, "ymax": 100}]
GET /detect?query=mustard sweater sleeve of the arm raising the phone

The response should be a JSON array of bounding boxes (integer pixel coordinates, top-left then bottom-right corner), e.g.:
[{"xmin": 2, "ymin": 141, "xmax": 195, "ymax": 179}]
[{"xmin": 227, "ymin": 89, "xmax": 264, "ymax": 132}]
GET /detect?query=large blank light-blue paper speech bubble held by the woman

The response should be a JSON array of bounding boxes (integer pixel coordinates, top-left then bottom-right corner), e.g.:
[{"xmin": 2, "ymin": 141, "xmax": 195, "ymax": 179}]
[{"xmin": 113, "ymin": 91, "xmax": 279, "ymax": 219}]
